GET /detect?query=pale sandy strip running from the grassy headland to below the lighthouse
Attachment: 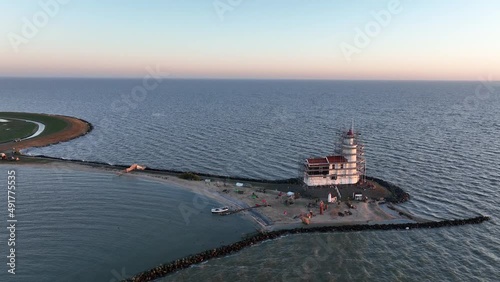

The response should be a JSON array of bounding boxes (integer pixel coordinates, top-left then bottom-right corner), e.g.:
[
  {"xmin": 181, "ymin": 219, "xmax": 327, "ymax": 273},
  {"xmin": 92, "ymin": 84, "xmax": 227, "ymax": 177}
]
[{"xmin": 9, "ymin": 155, "xmax": 418, "ymax": 231}]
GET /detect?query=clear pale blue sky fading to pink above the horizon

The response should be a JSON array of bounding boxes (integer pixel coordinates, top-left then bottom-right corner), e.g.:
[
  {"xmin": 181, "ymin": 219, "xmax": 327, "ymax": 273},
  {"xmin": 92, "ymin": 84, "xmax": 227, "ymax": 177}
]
[{"xmin": 0, "ymin": 0, "xmax": 500, "ymax": 80}]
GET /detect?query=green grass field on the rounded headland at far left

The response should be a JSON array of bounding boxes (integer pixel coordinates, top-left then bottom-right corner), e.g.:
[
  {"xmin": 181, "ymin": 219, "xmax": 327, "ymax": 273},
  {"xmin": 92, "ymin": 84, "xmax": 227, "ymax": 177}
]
[{"xmin": 0, "ymin": 112, "xmax": 68, "ymax": 143}]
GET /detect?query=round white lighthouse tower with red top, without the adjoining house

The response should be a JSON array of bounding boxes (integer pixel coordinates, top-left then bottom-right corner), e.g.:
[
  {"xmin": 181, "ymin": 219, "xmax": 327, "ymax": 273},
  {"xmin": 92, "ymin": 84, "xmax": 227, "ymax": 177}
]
[{"xmin": 341, "ymin": 127, "xmax": 359, "ymax": 184}]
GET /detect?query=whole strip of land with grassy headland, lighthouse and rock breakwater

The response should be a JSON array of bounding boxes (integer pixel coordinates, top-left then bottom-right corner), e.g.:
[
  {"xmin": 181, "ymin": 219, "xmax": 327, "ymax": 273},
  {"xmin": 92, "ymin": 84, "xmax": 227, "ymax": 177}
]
[{"xmin": 0, "ymin": 112, "xmax": 489, "ymax": 281}]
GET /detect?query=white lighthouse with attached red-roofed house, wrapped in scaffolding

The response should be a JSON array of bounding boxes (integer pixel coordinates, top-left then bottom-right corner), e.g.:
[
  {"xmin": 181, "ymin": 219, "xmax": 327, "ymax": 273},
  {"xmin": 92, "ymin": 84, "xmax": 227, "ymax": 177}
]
[{"xmin": 304, "ymin": 126, "xmax": 365, "ymax": 186}]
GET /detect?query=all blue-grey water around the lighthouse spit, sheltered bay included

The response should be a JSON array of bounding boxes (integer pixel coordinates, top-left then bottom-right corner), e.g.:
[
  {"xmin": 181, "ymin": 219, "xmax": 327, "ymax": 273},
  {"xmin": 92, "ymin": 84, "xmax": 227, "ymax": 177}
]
[{"xmin": 0, "ymin": 78, "xmax": 500, "ymax": 281}]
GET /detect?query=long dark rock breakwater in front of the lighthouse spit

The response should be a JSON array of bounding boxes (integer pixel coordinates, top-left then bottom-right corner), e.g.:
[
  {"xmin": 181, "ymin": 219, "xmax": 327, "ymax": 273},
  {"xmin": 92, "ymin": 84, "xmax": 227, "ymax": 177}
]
[{"xmin": 123, "ymin": 215, "xmax": 490, "ymax": 282}]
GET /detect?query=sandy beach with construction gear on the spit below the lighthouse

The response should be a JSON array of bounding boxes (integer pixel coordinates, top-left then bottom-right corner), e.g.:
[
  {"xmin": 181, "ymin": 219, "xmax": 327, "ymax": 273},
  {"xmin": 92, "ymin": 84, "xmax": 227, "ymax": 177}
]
[{"xmin": 61, "ymin": 164, "xmax": 419, "ymax": 231}]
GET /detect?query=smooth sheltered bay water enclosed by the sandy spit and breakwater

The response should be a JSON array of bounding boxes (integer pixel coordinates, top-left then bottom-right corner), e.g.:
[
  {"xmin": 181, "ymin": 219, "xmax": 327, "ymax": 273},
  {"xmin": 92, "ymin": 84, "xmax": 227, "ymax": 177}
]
[{"xmin": 0, "ymin": 164, "xmax": 254, "ymax": 281}]
